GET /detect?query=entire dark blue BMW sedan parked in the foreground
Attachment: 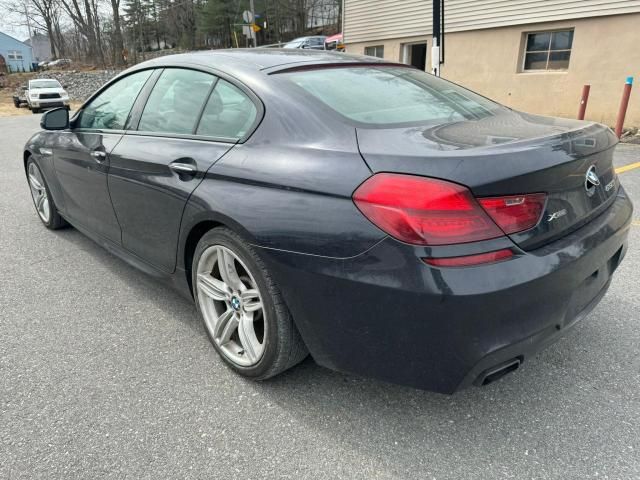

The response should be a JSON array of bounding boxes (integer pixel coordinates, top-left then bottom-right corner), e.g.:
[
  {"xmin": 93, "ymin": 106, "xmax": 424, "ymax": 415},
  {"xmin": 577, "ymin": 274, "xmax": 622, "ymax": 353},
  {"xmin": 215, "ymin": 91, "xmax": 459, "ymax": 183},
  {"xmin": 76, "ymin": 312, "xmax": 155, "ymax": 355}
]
[{"xmin": 24, "ymin": 50, "xmax": 632, "ymax": 393}]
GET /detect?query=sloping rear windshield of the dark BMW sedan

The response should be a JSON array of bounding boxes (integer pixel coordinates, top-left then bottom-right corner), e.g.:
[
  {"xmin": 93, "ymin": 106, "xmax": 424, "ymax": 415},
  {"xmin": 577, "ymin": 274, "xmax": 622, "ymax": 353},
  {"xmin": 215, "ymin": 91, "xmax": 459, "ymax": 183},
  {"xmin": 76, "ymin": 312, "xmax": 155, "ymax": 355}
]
[{"xmin": 284, "ymin": 66, "xmax": 505, "ymax": 125}]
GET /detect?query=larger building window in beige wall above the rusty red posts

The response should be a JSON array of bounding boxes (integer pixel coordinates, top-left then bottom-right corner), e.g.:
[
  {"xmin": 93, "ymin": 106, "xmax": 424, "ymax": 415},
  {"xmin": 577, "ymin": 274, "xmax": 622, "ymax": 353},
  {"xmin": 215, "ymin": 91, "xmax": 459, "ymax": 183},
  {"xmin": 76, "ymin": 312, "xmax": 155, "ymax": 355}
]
[{"xmin": 523, "ymin": 30, "xmax": 573, "ymax": 71}]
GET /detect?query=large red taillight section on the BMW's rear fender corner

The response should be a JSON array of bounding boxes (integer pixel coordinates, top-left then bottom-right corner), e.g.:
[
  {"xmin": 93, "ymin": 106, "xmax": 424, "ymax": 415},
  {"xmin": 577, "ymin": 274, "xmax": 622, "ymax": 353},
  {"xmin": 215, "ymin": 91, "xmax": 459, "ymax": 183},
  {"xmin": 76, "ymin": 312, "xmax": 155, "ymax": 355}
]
[{"xmin": 353, "ymin": 173, "xmax": 504, "ymax": 245}]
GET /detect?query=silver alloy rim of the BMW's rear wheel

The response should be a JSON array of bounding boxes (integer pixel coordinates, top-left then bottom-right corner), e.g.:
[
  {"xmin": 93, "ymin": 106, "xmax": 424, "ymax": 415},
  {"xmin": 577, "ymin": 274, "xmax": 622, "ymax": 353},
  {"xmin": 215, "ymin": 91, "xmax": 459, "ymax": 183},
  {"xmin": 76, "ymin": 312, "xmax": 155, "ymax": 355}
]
[{"xmin": 196, "ymin": 245, "xmax": 267, "ymax": 367}]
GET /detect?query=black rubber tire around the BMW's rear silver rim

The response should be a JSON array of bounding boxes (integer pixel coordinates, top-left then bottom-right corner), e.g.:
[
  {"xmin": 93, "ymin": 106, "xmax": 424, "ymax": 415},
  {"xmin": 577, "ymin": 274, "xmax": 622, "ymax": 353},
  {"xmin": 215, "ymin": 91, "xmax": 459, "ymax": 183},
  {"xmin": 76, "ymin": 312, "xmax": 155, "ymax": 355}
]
[{"xmin": 191, "ymin": 227, "xmax": 309, "ymax": 380}]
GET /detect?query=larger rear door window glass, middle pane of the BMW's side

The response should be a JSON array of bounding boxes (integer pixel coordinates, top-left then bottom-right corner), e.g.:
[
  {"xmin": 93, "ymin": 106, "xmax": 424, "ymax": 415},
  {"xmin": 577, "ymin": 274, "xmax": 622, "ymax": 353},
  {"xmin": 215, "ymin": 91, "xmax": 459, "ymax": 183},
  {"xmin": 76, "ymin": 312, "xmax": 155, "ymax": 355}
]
[{"xmin": 138, "ymin": 68, "xmax": 216, "ymax": 135}]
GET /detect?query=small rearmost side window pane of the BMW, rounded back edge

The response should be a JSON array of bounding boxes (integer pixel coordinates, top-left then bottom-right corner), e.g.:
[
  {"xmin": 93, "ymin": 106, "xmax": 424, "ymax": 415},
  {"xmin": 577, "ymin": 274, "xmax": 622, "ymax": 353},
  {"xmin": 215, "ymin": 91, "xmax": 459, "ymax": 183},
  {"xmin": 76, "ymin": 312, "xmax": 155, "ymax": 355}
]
[{"xmin": 196, "ymin": 79, "xmax": 258, "ymax": 139}]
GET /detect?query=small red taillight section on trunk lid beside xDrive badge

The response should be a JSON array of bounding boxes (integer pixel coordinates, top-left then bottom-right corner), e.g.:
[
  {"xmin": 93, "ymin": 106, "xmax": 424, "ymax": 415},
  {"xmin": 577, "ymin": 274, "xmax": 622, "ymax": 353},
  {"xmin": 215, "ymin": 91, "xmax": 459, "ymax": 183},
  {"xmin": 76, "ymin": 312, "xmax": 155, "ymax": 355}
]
[{"xmin": 478, "ymin": 193, "xmax": 546, "ymax": 235}]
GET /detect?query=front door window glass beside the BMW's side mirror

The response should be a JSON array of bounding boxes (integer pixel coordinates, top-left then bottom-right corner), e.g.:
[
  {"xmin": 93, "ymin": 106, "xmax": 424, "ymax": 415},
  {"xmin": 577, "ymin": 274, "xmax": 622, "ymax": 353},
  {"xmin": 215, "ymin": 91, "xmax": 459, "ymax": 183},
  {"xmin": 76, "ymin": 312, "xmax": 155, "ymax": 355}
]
[{"xmin": 78, "ymin": 70, "xmax": 151, "ymax": 130}]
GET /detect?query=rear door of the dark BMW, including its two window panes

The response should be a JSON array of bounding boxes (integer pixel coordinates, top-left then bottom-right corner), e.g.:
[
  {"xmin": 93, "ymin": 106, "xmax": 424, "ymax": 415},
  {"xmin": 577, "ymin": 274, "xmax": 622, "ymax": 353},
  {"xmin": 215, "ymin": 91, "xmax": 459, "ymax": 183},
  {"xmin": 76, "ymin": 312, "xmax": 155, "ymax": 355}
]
[{"xmin": 109, "ymin": 68, "xmax": 259, "ymax": 272}]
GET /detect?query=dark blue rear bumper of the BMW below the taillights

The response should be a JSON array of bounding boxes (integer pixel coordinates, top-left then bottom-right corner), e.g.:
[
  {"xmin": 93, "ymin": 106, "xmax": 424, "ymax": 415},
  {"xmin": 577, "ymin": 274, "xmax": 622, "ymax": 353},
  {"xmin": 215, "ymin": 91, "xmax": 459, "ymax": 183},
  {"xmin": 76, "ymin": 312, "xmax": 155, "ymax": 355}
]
[{"xmin": 262, "ymin": 188, "xmax": 633, "ymax": 393}]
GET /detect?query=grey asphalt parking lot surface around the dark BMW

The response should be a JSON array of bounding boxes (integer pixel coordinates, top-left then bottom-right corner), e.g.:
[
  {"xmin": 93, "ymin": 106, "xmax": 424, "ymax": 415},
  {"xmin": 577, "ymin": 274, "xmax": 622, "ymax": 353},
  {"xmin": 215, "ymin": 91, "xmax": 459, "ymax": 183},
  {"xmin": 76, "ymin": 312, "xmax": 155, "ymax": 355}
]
[{"xmin": 0, "ymin": 115, "xmax": 640, "ymax": 480}]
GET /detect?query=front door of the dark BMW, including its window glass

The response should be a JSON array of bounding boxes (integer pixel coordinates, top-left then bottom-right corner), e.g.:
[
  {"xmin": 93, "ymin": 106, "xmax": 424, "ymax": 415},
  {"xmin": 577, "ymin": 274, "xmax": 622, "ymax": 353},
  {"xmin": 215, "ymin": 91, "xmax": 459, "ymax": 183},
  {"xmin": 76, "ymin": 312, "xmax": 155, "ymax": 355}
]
[{"xmin": 53, "ymin": 70, "xmax": 152, "ymax": 244}]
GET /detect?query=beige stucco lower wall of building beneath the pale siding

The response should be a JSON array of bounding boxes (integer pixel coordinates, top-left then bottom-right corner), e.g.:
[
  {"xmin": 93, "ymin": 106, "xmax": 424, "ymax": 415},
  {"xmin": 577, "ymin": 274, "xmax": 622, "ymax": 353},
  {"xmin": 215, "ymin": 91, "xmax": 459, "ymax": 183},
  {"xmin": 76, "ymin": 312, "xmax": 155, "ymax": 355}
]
[{"xmin": 347, "ymin": 14, "xmax": 640, "ymax": 127}]
